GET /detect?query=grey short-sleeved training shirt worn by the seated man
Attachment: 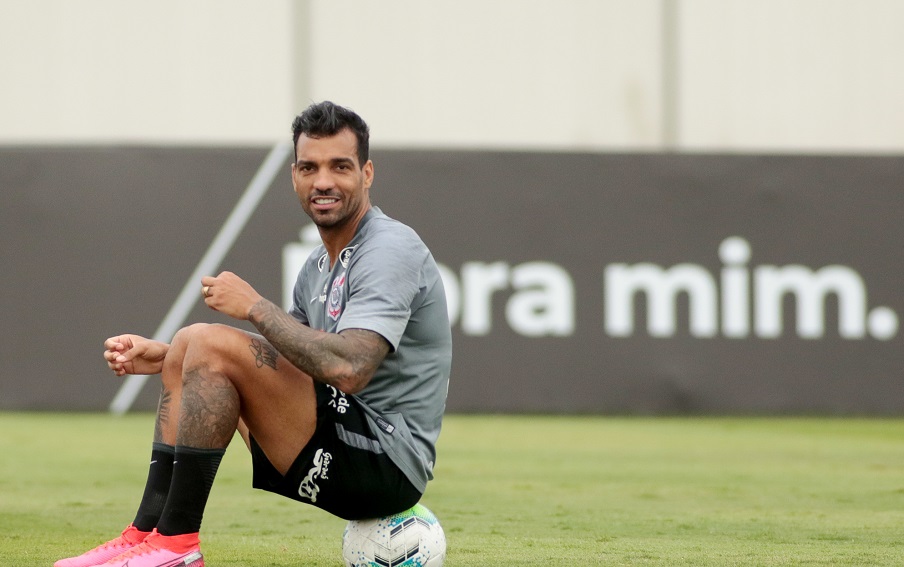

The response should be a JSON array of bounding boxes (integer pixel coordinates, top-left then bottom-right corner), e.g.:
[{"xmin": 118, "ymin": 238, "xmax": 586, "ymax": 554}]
[{"xmin": 290, "ymin": 207, "xmax": 452, "ymax": 492}]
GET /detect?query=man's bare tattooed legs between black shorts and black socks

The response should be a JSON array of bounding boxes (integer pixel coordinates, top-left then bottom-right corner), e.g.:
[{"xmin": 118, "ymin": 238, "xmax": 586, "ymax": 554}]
[{"xmin": 158, "ymin": 323, "xmax": 317, "ymax": 473}]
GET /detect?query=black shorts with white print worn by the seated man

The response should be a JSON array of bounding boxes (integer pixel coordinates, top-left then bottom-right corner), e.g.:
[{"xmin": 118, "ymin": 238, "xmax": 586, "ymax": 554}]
[{"xmin": 251, "ymin": 382, "xmax": 421, "ymax": 520}]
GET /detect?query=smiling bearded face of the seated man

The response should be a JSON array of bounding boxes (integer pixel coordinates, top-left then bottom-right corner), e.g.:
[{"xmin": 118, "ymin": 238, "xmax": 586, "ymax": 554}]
[{"xmin": 292, "ymin": 128, "xmax": 374, "ymax": 229}]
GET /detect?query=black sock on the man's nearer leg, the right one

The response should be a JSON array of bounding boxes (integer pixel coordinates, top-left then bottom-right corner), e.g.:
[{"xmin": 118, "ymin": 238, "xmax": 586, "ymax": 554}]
[{"xmin": 157, "ymin": 445, "xmax": 226, "ymax": 535}]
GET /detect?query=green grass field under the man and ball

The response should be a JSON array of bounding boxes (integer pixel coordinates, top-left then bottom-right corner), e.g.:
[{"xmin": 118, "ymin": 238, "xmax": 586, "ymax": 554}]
[{"xmin": 0, "ymin": 413, "xmax": 904, "ymax": 567}]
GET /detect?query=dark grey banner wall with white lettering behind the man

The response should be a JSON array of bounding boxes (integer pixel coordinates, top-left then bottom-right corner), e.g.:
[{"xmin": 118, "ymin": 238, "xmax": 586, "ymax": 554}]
[{"xmin": 0, "ymin": 147, "xmax": 904, "ymax": 415}]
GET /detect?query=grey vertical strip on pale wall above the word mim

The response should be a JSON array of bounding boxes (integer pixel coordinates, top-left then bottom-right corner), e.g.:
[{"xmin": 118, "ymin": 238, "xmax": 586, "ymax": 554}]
[{"xmin": 660, "ymin": 0, "xmax": 681, "ymax": 151}]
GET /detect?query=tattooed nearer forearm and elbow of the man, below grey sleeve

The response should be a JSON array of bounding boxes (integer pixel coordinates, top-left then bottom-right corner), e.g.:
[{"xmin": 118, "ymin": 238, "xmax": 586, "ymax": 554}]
[{"xmin": 248, "ymin": 299, "xmax": 389, "ymax": 394}]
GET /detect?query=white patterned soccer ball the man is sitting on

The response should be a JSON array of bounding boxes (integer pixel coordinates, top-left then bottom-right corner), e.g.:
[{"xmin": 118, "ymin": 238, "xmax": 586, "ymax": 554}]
[{"xmin": 342, "ymin": 504, "xmax": 446, "ymax": 567}]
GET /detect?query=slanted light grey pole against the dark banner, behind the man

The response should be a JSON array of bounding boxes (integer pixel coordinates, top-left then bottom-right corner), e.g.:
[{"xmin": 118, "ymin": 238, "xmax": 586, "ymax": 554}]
[{"xmin": 110, "ymin": 143, "xmax": 293, "ymax": 415}]
